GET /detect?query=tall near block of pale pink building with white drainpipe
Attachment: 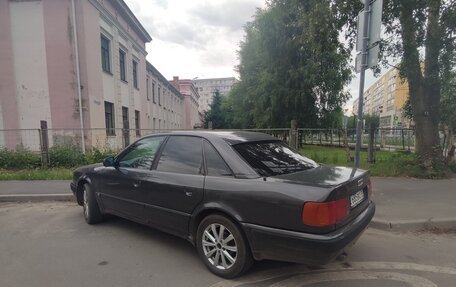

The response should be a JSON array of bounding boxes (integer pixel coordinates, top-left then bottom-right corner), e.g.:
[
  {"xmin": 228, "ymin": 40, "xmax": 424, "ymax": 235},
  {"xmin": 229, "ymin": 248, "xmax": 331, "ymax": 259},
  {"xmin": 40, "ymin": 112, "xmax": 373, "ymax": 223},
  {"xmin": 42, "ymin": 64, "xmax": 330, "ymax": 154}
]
[{"xmin": 0, "ymin": 0, "xmax": 152, "ymax": 151}]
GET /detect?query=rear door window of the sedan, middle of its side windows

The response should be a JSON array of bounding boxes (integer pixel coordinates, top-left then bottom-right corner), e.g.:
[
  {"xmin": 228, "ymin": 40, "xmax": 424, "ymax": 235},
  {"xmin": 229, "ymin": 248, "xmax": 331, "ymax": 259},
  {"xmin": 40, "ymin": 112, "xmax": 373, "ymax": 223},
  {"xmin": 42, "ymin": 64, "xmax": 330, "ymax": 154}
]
[{"xmin": 157, "ymin": 136, "xmax": 203, "ymax": 174}]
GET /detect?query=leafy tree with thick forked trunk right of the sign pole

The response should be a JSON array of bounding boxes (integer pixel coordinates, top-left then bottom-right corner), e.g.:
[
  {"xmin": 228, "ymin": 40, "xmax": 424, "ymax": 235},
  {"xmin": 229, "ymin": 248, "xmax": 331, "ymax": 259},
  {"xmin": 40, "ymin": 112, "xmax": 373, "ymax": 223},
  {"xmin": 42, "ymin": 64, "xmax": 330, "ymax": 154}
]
[{"xmin": 333, "ymin": 0, "xmax": 456, "ymax": 169}]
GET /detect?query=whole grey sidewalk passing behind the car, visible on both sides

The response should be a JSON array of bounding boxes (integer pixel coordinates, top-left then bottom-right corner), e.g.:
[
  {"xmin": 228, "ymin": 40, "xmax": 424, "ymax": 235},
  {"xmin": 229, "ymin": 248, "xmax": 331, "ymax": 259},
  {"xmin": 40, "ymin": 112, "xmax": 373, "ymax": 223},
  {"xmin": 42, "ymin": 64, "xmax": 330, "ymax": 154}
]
[{"xmin": 0, "ymin": 177, "xmax": 456, "ymax": 231}]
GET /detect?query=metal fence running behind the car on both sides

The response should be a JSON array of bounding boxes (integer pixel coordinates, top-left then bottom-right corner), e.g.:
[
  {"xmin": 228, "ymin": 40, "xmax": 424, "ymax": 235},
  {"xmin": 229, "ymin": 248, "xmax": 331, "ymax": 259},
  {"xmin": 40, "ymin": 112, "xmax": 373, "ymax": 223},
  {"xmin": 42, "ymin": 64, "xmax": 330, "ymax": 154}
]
[{"xmin": 0, "ymin": 128, "xmax": 454, "ymax": 156}]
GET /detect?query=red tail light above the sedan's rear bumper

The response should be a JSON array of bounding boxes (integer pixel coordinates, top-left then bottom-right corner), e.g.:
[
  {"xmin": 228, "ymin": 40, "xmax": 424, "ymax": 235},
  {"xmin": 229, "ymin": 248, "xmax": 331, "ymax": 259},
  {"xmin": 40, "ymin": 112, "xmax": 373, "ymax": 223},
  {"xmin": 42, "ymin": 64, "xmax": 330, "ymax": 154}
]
[{"xmin": 302, "ymin": 198, "xmax": 348, "ymax": 226}]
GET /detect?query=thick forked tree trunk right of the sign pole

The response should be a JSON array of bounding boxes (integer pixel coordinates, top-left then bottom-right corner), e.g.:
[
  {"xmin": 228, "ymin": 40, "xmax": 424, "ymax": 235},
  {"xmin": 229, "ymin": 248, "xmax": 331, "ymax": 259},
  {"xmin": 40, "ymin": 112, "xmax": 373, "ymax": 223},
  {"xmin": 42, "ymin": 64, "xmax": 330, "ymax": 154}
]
[{"xmin": 399, "ymin": 0, "xmax": 443, "ymax": 169}]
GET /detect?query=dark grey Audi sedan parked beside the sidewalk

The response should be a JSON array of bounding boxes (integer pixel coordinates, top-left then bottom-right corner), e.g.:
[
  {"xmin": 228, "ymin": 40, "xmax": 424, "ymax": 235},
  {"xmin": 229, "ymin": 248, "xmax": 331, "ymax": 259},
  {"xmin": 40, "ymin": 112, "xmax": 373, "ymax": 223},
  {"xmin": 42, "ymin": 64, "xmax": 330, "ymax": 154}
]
[{"xmin": 71, "ymin": 131, "xmax": 375, "ymax": 278}]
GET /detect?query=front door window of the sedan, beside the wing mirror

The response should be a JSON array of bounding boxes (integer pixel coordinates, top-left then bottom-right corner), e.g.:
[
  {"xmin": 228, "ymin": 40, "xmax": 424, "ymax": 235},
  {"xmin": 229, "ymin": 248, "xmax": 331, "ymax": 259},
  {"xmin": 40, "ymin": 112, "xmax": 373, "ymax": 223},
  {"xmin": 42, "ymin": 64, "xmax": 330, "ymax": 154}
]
[{"xmin": 119, "ymin": 137, "xmax": 165, "ymax": 169}]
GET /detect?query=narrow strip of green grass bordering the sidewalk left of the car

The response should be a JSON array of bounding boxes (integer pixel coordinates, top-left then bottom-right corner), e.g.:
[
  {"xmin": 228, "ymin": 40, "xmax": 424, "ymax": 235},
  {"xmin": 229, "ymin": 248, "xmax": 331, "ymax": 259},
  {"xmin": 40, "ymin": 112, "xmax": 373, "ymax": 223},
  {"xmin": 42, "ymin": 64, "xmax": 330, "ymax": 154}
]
[{"xmin": 0, "ymin": 168, "xmax": 73, "ymax": 180}]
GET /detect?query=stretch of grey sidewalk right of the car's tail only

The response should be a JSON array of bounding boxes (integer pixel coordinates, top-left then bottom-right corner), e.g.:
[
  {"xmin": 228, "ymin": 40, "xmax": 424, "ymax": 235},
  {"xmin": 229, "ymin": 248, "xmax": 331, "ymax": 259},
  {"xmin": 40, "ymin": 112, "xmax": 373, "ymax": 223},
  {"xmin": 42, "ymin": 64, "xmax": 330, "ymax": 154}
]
[{"xmin": 371, "ymin": 177, "xmax": 456, "ymax": 231}]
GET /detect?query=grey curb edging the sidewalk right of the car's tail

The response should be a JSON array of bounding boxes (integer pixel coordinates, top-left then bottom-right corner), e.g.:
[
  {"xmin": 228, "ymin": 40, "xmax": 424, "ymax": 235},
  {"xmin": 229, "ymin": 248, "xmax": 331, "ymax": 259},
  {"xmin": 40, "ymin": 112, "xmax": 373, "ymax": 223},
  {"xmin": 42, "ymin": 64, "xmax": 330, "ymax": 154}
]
[{"xmin": 369, "ymin": 218, "xmax": 456, "ymax": 232}]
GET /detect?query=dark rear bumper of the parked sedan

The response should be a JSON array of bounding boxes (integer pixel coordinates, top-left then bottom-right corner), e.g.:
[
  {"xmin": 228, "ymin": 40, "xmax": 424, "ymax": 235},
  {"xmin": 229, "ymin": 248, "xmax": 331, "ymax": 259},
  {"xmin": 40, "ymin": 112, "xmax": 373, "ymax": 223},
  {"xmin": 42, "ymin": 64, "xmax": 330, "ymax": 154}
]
[{"xmin": 242, "ymin": 202, "xmax": 375, "ymax": 265}]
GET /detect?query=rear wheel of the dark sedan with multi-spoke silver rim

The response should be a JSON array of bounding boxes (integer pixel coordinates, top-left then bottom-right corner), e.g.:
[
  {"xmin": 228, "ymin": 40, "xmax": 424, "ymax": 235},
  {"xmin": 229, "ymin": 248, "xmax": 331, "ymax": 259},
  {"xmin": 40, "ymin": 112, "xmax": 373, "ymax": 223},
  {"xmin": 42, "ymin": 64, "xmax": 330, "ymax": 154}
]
[{"xmin": 196, "ymin": 214, "xmax": 253, "ymax": 279}]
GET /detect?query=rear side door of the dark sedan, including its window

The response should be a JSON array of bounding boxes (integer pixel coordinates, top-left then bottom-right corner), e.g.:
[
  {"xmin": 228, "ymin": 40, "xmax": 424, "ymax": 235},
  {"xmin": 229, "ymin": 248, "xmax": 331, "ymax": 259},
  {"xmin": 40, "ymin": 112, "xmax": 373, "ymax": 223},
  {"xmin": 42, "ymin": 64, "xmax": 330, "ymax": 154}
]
[{"xmin": 139, "ymin": 135, "xmax": 204, "ymax": 236}]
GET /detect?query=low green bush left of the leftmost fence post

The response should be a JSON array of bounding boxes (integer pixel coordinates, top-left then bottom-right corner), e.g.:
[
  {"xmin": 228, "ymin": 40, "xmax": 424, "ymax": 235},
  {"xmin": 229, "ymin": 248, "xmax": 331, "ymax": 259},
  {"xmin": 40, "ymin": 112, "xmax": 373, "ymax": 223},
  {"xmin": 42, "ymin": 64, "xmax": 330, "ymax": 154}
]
[{"xmin": 0, "ymin": 148, "xmax": 41, "ymax": 169}]
